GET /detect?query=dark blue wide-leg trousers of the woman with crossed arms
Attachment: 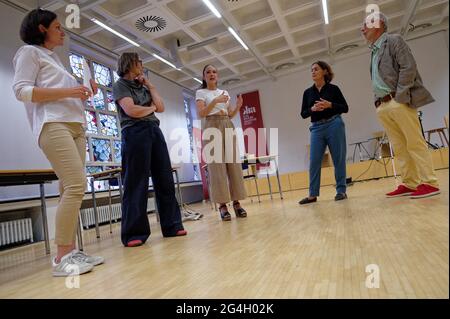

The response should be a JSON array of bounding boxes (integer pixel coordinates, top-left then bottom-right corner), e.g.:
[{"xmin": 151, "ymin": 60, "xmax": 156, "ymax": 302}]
[{"xmin": 121, "ymin": 121, "xmax": 183, "ymax": 245}]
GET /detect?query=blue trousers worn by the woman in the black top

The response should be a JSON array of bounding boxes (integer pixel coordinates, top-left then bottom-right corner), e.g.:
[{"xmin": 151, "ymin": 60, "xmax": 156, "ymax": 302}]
[{"xmin": 309, "ymin": 115, "xmax": 347, "ymax": 197}]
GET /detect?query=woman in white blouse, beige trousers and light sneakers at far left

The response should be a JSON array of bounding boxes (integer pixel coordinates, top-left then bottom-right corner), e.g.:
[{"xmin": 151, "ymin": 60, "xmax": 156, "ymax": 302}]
[{"xmin": 13, "ymin": 9, "xmax": 104, "ymax": 276}]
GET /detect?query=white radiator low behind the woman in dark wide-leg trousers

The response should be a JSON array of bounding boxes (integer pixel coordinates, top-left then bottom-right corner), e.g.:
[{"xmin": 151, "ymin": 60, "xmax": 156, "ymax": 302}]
[{"xmin": 81, "ymin": 198, "xmax": 155, "ymax": 229}]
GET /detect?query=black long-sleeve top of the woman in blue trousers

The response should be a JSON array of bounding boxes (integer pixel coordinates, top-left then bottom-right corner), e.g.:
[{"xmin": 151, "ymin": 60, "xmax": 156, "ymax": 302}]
[{"xmin": 301, "ymin": 83, "xmax": 348, "ymax": 122}]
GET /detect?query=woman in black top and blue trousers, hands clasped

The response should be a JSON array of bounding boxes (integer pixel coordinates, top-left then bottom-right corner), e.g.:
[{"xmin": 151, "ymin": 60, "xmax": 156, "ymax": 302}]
[{"xmin": 299, "ymin": 61, "xmax": 348, "ymax": 205}]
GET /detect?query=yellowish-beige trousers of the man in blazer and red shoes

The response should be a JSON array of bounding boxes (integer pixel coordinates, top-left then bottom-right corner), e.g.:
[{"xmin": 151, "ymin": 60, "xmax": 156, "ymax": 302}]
[{"xmin": 377, "ymin": 99, "xmax": 438, "ymax": 189}]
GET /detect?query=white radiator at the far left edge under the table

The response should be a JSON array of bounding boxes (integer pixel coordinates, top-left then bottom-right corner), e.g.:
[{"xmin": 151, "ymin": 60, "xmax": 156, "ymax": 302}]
[{"xmin": 0, "ymin": 218, "xmax": 33, "ymax": 247}]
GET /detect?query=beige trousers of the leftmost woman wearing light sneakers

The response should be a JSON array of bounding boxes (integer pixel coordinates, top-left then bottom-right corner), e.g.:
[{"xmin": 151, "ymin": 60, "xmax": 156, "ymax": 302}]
[{"xmin": 39, "ymin": 123, "xmax": 86, "ymax": 245}]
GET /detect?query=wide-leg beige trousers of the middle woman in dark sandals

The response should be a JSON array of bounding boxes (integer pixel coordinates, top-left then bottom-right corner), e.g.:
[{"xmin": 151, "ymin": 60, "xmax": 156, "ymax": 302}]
[{"xmin": 202, "ymin": 115, "xmax": 247, "ymax": 204}]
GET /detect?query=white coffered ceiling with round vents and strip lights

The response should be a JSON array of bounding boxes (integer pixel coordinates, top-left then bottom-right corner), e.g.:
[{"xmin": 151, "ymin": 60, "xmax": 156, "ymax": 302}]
[{"xmin": 7, "ymin": 0, "xmax": 449, "ymax": 89}]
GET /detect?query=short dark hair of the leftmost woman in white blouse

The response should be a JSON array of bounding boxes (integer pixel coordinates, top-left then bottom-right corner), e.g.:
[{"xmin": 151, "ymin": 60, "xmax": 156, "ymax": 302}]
[{"xmin": 20, "ymin": 8, "xmax": 57, "ymax": 45}]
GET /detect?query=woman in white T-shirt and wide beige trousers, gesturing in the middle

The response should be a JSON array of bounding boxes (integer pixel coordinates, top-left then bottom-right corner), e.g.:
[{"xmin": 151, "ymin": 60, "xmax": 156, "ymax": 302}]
[{"xmin": 195, "ymin": 65, "xmax": 247, "ymax": 221}]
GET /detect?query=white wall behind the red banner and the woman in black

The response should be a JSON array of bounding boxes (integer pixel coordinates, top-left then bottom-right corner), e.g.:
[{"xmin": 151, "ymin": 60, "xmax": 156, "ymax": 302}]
[{"xmin": 230, "ymin": 32, "xmax": 449, "ymax": 173}]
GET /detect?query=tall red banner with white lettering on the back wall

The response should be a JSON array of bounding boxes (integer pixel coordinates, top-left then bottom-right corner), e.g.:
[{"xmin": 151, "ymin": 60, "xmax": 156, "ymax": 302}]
[{"xmin": 240, "ymin": 91, "xmax": 267, "ymax": 166}]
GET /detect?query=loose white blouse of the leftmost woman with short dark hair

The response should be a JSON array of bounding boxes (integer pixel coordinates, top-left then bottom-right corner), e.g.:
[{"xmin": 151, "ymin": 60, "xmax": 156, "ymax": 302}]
[{"xmin": 13, "ymin": 45, "xmax": 86, "ymax": 141}]
